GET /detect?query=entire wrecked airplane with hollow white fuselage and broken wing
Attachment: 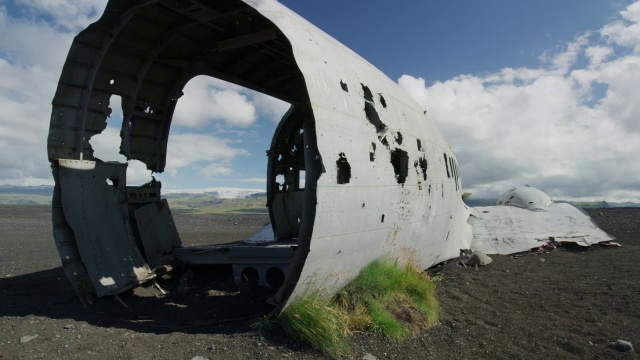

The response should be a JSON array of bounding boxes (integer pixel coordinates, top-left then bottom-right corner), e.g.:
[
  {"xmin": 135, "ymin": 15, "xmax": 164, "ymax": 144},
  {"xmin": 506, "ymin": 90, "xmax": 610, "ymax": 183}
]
[{"xmin": 48, "ymin": 0, "xmax": 611, "ymax": 305}]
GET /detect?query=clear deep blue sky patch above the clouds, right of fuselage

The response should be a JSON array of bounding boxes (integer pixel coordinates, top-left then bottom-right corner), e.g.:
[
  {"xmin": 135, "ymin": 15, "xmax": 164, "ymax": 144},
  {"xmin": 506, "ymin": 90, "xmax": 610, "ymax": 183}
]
[{"xmin": 281, "ymin": 0, "xmax": 630, "ymax": 81}]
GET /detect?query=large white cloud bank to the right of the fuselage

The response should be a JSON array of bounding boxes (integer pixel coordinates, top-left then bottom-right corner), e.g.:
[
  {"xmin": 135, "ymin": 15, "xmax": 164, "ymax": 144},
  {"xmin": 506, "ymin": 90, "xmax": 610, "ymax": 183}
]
[{"xmin": 398, "ymin": 2, "xmax": 640, "ymax": 200}]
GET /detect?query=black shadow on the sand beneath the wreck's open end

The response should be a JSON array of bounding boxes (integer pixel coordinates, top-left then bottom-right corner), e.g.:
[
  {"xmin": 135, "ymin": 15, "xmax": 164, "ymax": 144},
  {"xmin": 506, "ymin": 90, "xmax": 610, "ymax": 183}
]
[{"xmin": 0, "ymin": 266, "xmax": 287, "ymax": 338}]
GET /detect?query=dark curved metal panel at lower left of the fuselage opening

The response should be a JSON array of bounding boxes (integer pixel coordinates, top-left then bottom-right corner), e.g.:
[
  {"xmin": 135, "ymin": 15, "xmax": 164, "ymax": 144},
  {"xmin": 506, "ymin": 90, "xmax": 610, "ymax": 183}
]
[{"xmin": 59, "ymin": 160, "xmax": 153, "ymax": 296}]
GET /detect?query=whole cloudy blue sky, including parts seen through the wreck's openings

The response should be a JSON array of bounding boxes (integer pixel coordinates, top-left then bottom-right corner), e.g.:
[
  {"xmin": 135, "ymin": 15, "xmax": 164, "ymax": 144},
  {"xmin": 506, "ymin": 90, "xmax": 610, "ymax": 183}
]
[{"xmin": 0, "ymin": 0, "xmax": 640, "ymax": 201}]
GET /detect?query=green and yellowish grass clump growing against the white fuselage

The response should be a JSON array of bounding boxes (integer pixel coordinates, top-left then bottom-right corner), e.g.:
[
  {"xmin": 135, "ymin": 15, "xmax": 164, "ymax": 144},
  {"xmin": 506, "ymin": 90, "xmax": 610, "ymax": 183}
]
[{"xmin": 268, "ymin": 259, "xmax": 439, "ymax": 358}]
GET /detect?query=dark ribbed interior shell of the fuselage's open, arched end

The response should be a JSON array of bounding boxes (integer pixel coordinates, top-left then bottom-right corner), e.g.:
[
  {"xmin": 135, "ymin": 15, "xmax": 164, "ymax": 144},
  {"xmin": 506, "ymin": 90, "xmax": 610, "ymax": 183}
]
[{"xmin": 48, "ymin": 0, "xmax": 321, "ymax": 301}]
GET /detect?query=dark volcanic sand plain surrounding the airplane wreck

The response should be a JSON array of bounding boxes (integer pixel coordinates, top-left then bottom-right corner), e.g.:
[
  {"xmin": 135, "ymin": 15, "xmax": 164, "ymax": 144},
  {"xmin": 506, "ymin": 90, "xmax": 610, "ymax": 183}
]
[{"xmin": 0, "ymin": 205, "xmax": 640, "ymax": 359}]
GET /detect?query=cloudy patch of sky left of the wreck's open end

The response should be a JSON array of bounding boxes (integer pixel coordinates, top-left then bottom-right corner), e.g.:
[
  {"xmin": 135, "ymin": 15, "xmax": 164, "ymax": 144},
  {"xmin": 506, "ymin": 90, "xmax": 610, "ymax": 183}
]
[{"xmin": 0, "ymin": 6, "xmax": 71, "ymax": 185}]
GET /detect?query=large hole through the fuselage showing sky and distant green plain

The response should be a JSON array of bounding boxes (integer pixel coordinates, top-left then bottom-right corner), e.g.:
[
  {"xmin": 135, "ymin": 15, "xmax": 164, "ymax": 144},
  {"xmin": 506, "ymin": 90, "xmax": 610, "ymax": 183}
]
[{"xmin": 159, "ymin": 76, "xmax": 302, "ymax": 292}]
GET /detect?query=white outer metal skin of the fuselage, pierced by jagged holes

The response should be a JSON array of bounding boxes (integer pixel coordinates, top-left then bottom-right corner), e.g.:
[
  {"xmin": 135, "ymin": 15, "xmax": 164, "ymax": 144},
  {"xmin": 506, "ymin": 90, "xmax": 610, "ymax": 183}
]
[{"xmin": 246, "ymin": 1, "xmax": 471, "ymax": 297}]
